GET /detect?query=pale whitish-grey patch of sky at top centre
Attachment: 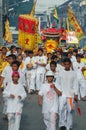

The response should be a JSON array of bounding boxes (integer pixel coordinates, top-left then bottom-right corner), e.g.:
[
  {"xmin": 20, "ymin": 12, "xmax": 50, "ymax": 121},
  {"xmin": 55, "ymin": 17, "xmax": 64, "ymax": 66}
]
[{"xmin": 35, "ymin": 0, "xmax": 68, "ymax": 12}]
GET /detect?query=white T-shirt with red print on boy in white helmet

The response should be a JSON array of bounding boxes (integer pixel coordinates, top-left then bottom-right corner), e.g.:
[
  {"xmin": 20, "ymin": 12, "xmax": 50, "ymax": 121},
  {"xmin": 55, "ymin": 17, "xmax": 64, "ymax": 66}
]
[{"xmin": 39, "ymin": 83, "xmax": 60, "ymax": 113}]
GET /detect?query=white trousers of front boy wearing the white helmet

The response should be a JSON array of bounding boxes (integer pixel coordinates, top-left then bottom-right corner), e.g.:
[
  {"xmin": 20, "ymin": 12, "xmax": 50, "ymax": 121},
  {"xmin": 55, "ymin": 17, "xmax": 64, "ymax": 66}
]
[{"xmin": 43, "ymin": 112, "xmax": 57, "ymax": 130}]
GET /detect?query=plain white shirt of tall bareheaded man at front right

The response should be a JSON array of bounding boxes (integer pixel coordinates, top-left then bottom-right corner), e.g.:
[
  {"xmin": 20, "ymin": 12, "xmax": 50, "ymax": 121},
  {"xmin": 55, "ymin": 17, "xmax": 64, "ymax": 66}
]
[{"xmin": 58, "ymin": 70, "xmax": 78, "ymax": 97}]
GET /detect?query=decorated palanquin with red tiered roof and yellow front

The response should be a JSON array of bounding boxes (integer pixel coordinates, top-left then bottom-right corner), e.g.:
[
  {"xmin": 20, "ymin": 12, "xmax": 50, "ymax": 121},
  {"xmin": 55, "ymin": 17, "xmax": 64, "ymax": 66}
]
[{"xmin": 42, "ymin": 28, "xmax": 61, "ymax": 52}]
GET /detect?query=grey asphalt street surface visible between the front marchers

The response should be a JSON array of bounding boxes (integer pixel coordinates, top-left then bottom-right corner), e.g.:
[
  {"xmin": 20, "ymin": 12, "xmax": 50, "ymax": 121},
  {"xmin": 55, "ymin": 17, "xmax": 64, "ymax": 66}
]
[{"xmin": 0, "ymin": 94, "xmax": 86, "ymax": 130}]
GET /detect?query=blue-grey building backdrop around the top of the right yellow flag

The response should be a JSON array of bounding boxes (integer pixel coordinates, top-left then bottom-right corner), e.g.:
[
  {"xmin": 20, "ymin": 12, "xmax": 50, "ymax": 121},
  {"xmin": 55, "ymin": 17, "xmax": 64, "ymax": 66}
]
[{"xmin": 58, "ymin": 0, "xmax": 86, "ymax": 34}]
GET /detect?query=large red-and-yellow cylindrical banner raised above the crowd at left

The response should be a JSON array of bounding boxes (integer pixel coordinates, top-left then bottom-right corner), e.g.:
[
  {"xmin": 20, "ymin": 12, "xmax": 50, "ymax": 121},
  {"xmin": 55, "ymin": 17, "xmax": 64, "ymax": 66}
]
[{"xmin": 18, "ymin": 14, "xmax": 38, "ymax": 50}]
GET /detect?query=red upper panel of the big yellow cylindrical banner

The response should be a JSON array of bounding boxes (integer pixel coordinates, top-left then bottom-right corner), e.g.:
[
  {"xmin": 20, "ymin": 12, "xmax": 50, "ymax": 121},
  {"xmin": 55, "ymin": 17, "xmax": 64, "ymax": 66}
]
[{"xmin": 18, "ymin": 17, "xmax": 36, "ymax": 34}]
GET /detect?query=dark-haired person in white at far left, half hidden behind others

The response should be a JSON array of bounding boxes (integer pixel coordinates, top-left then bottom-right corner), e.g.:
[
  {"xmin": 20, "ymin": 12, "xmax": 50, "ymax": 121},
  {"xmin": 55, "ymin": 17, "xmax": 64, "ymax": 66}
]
[{"xmin": 0, "ymin": 54, "xmax": 16, "ymax": 120}]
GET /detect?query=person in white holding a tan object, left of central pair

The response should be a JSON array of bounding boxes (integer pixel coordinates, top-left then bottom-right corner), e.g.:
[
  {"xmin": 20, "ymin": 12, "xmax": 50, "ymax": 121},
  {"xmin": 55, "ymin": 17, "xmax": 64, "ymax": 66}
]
[{"xmin": 25, "ymin": 51, "xmax": 37, "ymax": 94}]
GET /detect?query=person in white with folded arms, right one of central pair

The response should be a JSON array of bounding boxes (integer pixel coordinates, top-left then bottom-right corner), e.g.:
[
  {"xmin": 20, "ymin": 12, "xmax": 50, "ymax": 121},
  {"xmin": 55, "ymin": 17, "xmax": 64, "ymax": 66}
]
[{"xmin": 35, "ymin": 48, "xmax": 47, "ymax": 91}]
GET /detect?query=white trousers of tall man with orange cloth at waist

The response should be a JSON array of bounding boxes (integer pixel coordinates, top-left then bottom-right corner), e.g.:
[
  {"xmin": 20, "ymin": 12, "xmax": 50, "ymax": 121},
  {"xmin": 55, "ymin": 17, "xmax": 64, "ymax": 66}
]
[{"xmin": 59, "ymin": 96, "xmax": 74, "ymax": 130}]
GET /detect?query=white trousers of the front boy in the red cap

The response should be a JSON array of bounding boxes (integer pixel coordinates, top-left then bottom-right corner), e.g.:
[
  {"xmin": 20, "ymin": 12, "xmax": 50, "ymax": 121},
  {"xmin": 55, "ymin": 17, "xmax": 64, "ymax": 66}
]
[{"xmin": 8, "ymin": 114, "xmax": 21, "ymax": 130}]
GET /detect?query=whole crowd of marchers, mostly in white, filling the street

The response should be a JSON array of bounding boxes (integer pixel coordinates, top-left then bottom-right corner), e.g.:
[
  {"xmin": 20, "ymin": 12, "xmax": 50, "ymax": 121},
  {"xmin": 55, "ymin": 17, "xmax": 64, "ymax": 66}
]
[{"xmin": 0, "ymin": 46, "xmax": 86, "ymax": 130}]
